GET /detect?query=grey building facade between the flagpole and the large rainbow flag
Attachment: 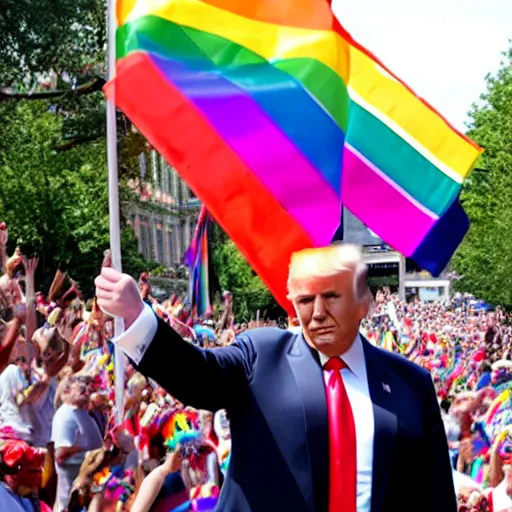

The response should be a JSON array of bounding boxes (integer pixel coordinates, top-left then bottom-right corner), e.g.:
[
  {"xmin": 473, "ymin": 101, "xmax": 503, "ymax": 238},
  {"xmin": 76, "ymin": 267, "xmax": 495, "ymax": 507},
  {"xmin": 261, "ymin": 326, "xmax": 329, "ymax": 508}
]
[{"xmin": 128, "ymin": 150, "xmax": 201, "ymax": 267}]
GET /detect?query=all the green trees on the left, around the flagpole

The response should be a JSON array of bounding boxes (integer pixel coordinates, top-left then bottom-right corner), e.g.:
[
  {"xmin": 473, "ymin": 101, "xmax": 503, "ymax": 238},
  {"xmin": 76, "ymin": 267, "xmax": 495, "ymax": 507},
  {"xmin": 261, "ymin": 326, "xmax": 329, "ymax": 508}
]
[{"xmin": 0, "ymin": 0, "xmax": 172, "ymax": 291}]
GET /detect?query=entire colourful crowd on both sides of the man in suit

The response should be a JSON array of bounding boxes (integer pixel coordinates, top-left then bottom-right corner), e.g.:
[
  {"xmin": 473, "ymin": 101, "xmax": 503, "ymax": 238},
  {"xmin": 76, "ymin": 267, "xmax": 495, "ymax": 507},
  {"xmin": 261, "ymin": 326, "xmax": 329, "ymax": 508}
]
[{"xmin": 0, "ymin": 233, "xmax": 512, "ymax": 512}]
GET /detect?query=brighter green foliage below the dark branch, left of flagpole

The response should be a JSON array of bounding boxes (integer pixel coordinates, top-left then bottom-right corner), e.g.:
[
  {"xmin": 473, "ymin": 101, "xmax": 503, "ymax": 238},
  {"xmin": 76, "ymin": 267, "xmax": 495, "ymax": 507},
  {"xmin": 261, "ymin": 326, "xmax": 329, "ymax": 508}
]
[{"xmin": 0, "ymin": 101, "xmax": 156, "ymax": 293}]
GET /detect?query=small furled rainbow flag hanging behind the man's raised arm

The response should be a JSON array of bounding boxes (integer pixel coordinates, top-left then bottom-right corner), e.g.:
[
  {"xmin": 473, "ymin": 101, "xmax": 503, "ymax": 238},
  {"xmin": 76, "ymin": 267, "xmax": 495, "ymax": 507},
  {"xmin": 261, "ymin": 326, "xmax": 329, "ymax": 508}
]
[{"xmin": 185, "ymin": 207, "xmax": 211, "ymax": 316}]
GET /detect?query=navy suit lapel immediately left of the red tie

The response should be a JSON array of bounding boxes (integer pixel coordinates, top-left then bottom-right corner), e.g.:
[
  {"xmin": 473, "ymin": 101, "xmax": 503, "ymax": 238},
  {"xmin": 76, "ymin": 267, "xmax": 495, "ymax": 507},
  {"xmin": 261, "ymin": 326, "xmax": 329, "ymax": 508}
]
[{"xmin": 288, "ymin": 335, "xmax": 329, "ymax": 511}]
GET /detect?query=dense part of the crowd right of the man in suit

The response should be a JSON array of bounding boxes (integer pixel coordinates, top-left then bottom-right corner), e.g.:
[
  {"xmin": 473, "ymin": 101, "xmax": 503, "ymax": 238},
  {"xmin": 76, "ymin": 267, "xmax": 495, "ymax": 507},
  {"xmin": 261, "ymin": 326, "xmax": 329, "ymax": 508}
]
[{"xmin": 363, "ymin": 292, "xmax": 512, "ymax": 512}]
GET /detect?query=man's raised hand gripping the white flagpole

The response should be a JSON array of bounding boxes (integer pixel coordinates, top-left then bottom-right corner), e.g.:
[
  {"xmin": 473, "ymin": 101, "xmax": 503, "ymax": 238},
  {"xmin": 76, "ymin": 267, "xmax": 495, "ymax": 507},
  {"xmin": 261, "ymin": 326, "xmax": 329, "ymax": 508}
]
[{"xmin": 94, "ymin": 267, "xmax": 144, "ymax": 329}]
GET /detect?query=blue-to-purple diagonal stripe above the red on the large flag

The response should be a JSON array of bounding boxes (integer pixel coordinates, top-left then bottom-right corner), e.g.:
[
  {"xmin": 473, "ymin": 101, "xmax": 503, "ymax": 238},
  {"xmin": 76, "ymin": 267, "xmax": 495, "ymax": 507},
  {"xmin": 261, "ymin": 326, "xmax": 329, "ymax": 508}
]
[{"xmin": 152, "ymin": 56, "xmax": 341, "ymax": 246}]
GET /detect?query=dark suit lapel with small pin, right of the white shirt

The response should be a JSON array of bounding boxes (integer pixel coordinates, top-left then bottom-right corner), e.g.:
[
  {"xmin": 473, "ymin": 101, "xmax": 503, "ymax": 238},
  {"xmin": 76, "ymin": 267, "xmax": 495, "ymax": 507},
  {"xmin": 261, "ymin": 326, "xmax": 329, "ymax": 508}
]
[{"xmin": 363, "ymin": 339, "xmax": 397, "ymax": 512}]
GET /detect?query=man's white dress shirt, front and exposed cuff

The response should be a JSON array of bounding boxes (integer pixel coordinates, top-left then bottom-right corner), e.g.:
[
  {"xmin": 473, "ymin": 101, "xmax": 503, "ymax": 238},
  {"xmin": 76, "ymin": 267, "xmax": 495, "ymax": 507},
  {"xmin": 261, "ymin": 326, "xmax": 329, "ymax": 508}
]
[{"xmin": 114, "ymin": 304, "xmax": 375, "ymax": 512}]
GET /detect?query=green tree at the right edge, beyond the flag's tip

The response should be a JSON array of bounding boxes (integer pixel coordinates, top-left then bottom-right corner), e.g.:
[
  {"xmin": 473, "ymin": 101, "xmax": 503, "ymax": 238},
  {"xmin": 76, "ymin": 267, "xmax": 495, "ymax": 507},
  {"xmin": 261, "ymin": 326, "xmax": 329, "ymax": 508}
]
[{"xmin": 452, "ymin": 43, "xmax": 512, "ymax": 305}]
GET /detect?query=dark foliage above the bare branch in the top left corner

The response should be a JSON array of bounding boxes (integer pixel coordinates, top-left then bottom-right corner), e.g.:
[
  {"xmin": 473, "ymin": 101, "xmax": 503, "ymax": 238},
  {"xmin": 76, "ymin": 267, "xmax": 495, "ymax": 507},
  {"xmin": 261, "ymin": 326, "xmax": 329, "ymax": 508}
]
[{"xmin": 0, "ymin": 0, "xmax": 106, "ymax": 89}]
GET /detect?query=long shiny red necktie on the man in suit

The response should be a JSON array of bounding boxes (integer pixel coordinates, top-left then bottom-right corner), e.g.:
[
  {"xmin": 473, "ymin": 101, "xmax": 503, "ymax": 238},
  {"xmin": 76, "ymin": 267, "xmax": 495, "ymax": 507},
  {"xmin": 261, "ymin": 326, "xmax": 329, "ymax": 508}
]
[{"xmin": 324, "ymin": 357, "xmax": 357, "ymax": 512}]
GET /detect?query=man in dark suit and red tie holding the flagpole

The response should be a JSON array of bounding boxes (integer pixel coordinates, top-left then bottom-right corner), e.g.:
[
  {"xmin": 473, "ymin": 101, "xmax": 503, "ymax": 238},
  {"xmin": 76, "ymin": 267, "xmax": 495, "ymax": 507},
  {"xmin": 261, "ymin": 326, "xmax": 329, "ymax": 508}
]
[{"xmin": 96, "ymin": 245, "xmax": 457, "ymax": 512}]
